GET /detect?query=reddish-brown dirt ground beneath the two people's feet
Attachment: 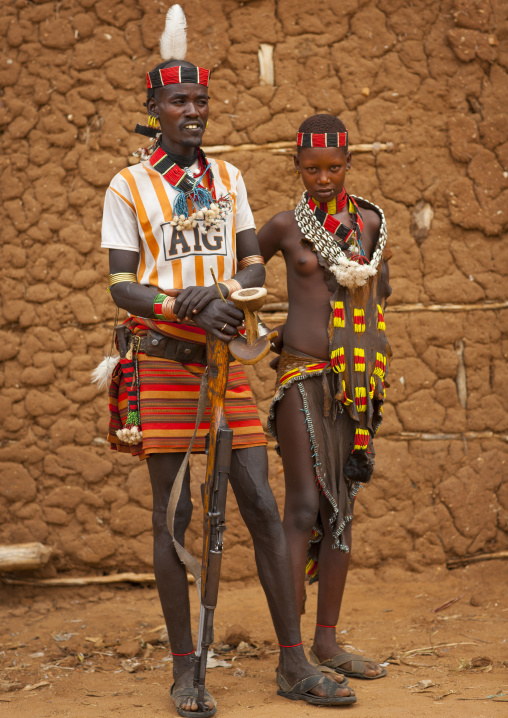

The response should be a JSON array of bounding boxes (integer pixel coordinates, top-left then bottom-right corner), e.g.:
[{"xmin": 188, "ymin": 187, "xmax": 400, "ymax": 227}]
[{"xmin": 0, "ymin": 561, "xmax": 508, "ymax": 718}]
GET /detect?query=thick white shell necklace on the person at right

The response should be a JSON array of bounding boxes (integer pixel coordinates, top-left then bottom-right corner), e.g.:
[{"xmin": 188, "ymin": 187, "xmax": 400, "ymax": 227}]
[{"xmin": 295, "ymin": 192, "xmax": 387, "ymax": 289}]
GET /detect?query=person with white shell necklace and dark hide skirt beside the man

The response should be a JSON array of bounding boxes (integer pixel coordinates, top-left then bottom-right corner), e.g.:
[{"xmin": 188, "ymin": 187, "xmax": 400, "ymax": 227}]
[{"xmin": 258, "ymin": 115, "xmax": 391, "ymax": 679}]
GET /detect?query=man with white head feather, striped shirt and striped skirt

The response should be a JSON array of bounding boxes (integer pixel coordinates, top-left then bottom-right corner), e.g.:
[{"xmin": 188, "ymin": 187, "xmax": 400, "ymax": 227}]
[{"xmin": 102, "ymin": 6, "xmax": 356, "ymax": 717}]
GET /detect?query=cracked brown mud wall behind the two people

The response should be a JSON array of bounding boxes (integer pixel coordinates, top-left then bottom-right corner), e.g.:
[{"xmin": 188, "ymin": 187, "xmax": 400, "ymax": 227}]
[{"xmin": 0, "ymin": 0, "xmax": 508, "ymax": 579}]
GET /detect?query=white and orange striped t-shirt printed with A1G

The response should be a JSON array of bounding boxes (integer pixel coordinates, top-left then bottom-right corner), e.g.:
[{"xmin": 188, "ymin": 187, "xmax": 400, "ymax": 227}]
[{"xmin": 101, "ymin": 159, "xmax": 255, "ymax": 291}]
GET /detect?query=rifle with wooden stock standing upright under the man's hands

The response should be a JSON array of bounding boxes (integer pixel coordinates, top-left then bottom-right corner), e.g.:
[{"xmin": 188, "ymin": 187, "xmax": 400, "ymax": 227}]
[{"xmin": 194, "ymin": 333, "xmax": 233, "ymax": 716}]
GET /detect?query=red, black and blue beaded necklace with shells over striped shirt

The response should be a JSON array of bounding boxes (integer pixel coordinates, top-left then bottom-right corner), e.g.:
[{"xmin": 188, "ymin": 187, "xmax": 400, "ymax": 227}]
[{"xmin": 149, "ymin": 140, "xmax": 232, "ymax": 231}]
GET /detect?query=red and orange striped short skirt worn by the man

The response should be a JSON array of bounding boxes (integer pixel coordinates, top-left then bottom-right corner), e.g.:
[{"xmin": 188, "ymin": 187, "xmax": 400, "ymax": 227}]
[{"xmin": 108, "ymin": 353, "xmax": 266, "ymax": 459}]
